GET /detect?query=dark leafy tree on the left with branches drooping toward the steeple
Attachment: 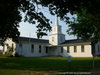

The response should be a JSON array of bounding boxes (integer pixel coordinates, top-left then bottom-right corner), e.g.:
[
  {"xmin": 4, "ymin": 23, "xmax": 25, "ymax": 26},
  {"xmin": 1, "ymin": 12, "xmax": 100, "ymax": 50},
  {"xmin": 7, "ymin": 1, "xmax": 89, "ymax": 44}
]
[{"xmin": 0, "ymin": 0, "xmax": 51, "ymax": 42}]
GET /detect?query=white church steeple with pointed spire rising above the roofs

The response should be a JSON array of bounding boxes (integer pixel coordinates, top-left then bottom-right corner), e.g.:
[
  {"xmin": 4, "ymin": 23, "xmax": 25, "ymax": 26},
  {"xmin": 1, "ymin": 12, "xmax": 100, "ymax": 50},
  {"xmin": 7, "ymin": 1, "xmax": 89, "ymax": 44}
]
[{"xmin": 49, "ymin": 15, "xmax": 65, "ymax": 45}]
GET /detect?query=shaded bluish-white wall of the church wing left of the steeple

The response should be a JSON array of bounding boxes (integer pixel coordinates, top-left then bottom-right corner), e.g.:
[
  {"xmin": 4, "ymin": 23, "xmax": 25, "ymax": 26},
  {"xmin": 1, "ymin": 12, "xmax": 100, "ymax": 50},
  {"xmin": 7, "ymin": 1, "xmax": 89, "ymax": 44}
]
[{"xmin": 16, "ymin": 43, "xmax": 48, "ymax": 57}]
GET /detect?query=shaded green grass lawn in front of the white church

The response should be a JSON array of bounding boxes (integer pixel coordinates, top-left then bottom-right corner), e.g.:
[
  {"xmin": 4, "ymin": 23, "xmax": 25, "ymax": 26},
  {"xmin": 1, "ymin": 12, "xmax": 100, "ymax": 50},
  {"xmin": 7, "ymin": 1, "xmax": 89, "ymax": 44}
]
[{"xmin": 0, "ymin": 55, "xmax": 100, "ymax": 75}]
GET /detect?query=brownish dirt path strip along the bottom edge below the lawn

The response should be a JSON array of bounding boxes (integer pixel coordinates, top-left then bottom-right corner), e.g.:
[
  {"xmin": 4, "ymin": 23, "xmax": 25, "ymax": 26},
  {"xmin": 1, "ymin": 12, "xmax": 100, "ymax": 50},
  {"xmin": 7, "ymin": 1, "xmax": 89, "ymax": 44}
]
[{"xmin": 13, "ymin": 69, "xmax": 100, "ymax": 75}]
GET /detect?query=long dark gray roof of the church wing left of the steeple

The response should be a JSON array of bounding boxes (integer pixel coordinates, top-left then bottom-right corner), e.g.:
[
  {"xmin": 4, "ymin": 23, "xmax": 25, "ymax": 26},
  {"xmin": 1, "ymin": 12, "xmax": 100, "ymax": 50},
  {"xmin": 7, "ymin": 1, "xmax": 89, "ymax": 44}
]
[{"xmin": 19, "ymin": 37, "xmax": 49, "ymax": 43}]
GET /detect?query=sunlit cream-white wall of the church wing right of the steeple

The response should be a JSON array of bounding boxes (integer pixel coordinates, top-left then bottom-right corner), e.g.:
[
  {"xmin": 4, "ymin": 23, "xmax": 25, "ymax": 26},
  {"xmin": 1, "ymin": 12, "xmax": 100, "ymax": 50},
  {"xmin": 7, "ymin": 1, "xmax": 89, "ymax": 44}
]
[{"xmin": 60, "ymin": 45, "xmax": 92, "ymax": 57}]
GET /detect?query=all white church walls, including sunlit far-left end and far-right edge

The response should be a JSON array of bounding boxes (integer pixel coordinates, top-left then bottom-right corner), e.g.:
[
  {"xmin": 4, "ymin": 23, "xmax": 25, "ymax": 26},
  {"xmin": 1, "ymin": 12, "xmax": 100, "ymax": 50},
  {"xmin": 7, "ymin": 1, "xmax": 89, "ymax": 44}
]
[{"xmin": 5, "ymin": 40, "xmax": 94, "ymax": 57}]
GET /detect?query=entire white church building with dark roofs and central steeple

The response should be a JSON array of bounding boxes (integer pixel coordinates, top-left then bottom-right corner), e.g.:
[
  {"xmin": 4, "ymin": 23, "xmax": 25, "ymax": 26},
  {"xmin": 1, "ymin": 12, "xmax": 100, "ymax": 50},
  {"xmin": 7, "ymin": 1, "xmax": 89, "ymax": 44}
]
[{"xmin": 3, "ymin": 17, "xmax": 100, "ymax": 57}]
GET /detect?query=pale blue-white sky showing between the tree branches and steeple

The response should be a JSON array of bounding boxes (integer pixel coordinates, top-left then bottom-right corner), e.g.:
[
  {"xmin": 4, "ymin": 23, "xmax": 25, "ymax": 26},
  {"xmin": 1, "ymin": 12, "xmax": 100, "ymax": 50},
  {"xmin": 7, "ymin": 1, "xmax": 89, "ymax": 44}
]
[{"xmin": 19, "ymin": 7, "xmax": 76, "ymax": 40}]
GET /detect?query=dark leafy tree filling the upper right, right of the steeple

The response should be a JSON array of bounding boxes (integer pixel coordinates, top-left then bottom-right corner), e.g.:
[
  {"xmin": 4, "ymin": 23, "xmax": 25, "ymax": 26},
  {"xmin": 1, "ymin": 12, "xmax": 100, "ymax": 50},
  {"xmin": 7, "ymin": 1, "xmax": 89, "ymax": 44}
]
[{"xmin": 40, "ymin": 0, "xmax": 100, "ymax": 41}]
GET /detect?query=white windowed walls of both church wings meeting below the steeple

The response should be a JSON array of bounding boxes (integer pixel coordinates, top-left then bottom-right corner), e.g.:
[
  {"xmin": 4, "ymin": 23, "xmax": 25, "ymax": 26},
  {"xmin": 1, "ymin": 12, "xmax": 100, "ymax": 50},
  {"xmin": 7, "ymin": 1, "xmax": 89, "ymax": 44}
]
[{"xmin": 17, "ymin": 43, "xmax": 92, "ymax": 57}]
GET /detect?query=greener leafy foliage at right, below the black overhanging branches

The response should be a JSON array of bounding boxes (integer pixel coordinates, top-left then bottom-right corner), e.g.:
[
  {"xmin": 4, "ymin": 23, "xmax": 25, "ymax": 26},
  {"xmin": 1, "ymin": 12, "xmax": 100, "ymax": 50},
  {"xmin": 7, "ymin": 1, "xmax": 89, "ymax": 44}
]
[{"xmin": 68, "ymin": 9, "xmax": 100, "ymax": 41}]
